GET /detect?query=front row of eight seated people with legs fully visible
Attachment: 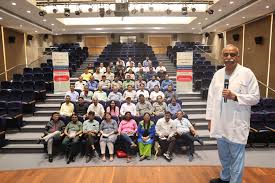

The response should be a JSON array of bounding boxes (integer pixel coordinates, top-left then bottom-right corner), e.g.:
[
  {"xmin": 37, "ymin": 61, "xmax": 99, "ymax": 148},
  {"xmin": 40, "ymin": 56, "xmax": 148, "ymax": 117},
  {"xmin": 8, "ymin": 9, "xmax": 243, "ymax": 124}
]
[{"xmin": 39, "ymin": 110, "xmax": 203, "ymax": 164}]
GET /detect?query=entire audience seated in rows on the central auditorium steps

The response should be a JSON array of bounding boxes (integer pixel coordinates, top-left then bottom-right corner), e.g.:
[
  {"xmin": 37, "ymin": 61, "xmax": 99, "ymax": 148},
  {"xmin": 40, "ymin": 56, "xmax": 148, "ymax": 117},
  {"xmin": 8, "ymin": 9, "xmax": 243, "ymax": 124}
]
[{"xmin": 39, "ymin": 58, "xmax": 203, "ymax": 163}]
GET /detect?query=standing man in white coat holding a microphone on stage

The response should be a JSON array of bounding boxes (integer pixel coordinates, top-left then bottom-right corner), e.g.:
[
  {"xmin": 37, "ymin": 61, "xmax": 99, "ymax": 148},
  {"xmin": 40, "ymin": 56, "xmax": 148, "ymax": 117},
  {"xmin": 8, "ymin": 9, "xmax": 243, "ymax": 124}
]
[{"xmin": 206, "ymin": 45, "xmax": 260, "ymax": 183}]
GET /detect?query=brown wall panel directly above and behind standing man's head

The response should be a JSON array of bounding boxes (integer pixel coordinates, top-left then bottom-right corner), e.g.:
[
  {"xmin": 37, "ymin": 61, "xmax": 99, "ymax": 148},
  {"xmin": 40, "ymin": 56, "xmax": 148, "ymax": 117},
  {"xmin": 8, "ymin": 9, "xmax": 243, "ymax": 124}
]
[{"xmin": 226, "ymin": 26, "xmax": 243, "ymax": 60}]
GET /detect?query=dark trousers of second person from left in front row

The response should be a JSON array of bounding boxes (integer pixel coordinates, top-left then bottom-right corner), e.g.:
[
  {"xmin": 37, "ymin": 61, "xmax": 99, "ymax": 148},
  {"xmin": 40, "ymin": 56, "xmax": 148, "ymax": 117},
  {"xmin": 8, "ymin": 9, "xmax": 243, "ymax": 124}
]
[{"xmin": 62, "ymin": 136, "xmax": 79, "ymax": 157}]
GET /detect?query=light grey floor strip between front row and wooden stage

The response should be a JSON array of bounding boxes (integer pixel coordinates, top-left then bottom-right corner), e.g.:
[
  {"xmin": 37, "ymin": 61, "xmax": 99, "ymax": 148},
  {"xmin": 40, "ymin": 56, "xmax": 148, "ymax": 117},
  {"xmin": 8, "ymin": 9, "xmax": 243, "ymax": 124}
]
[{"xmin": 0, "ymin": 148, "xmax": 275, "ymax": 170}]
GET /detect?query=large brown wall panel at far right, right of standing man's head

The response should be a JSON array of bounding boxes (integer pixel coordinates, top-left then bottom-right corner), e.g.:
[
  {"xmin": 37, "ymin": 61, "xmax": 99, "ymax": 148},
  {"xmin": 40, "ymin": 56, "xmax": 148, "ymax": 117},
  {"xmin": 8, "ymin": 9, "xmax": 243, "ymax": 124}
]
[{"xmin": 244, "ymin": 16, "xmax": 271, "ymax": 97}]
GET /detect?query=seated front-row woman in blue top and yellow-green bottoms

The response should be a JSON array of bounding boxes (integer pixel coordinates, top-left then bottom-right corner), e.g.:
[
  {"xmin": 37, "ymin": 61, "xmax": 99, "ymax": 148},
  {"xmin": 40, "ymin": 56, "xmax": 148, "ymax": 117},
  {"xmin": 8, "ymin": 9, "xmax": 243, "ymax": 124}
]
[{"xmin": 138, "ymin": 112, "xmax": 156, "ymax": 161}]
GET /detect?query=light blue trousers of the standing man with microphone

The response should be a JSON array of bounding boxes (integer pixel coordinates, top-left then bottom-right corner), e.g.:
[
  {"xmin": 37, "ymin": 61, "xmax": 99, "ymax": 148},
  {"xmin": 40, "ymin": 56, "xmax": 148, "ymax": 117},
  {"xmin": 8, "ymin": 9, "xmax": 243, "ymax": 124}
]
[{"xmin": 217, "ymin": 137, "xmax": 245, "ymax": 183}]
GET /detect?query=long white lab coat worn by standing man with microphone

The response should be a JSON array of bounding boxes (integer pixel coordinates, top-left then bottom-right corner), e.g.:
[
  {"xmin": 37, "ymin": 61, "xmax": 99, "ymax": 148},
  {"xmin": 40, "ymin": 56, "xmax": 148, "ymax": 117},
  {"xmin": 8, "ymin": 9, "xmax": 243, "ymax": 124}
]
[{"xmin": 206, "ymin": 64, "xmax": 260, "ymax": 144}]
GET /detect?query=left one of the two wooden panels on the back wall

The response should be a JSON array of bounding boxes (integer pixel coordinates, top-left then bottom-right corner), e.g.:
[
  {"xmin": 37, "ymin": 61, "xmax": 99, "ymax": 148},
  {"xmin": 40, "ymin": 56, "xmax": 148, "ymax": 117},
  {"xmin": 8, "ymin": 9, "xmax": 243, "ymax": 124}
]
[{"xmin": 85, "ymin": 36, "xmax": 108, "ymax": 55}]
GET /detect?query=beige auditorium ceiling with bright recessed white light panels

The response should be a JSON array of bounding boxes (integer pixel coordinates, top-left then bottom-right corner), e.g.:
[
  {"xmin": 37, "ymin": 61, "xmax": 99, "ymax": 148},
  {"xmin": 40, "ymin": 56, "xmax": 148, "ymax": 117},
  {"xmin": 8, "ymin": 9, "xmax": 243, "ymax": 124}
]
[{"xmin": 0, "ymin": 0, "xmax": 275, "ymax": 34}]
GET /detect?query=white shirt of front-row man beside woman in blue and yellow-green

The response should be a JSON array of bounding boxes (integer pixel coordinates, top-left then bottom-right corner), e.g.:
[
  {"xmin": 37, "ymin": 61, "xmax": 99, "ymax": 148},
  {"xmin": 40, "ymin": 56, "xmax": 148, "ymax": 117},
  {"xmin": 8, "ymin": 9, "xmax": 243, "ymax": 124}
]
[{"xmin": 156, "ymin": 117, "xmax": 176, "ymax": 136}]
